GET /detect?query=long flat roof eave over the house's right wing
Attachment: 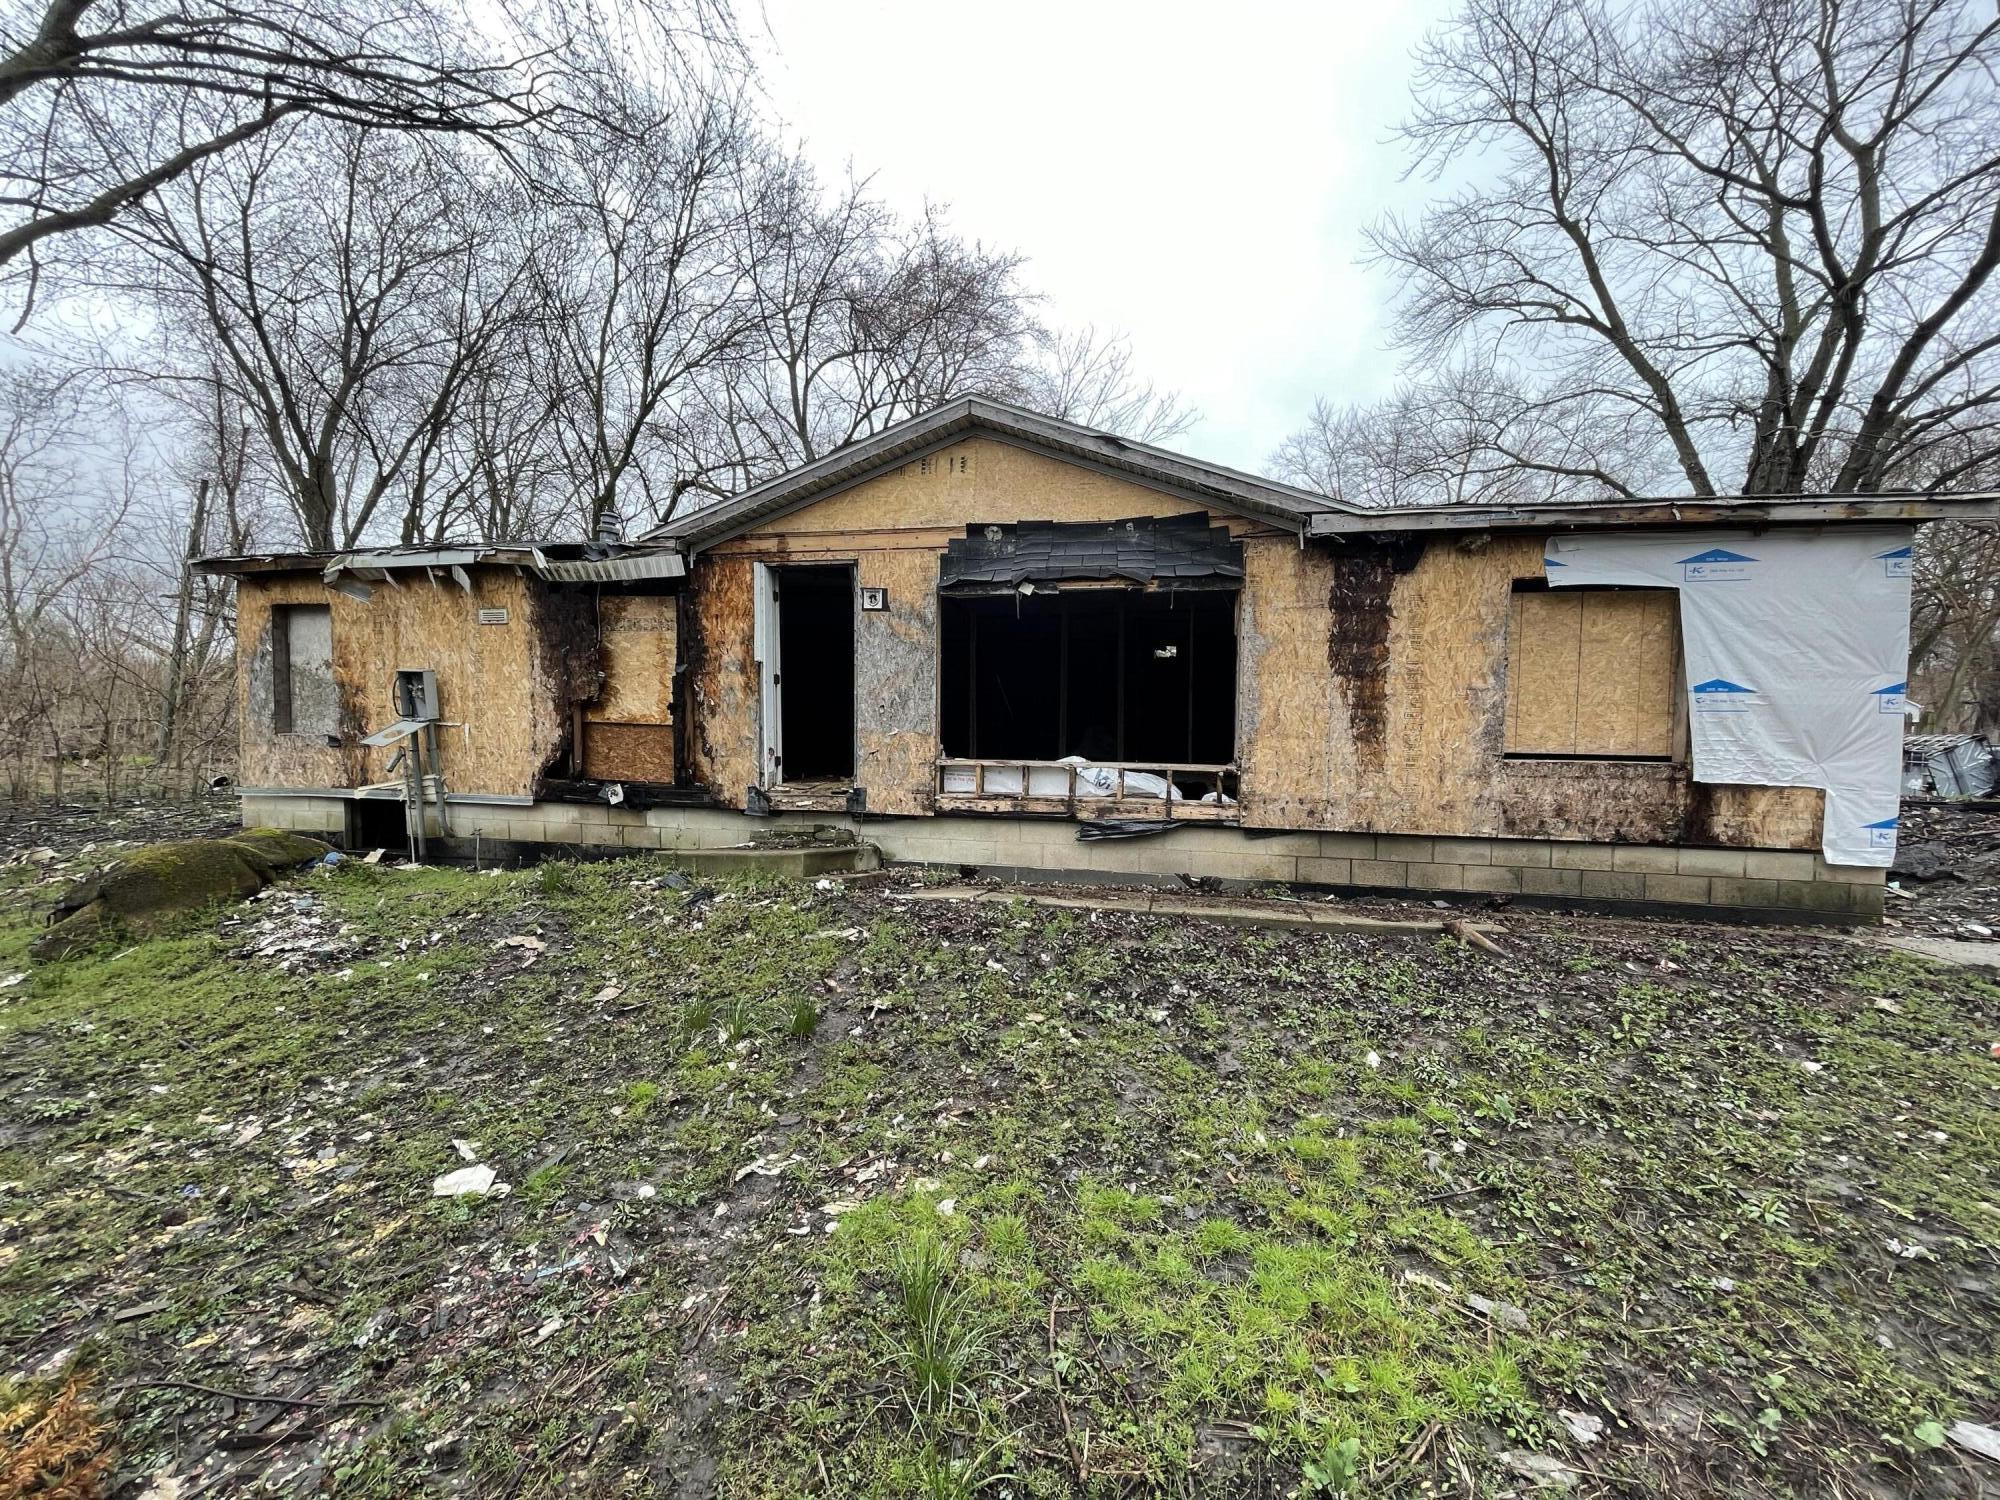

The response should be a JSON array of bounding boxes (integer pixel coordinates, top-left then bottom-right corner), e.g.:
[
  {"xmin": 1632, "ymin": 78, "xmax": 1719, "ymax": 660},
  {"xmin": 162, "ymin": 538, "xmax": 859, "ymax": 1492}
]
[{"xmin": 1306, "ymin": 494, "xmax": 2000, "ymax": 536}]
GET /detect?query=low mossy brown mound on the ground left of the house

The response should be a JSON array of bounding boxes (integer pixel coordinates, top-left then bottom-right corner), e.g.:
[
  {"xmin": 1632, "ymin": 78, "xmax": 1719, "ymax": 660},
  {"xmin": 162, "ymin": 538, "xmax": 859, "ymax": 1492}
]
[{"xmin": 34, "ymin": 828, "xmax": 330, "ymax": 958}]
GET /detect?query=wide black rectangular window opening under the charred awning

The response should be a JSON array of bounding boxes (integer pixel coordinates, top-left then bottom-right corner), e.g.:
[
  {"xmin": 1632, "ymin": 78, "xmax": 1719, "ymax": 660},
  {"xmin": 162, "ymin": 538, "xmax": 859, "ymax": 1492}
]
[{"xmin": 938, "ymin": 588, "xmax": 1236, "ymax": 766}]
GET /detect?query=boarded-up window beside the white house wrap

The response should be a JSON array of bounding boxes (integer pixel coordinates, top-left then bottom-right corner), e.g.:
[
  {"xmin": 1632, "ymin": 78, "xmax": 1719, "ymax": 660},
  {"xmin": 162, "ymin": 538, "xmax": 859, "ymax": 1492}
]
[{"xmin": 1506, "ymin": 588, "xmax": 1680, "ymax": 760}]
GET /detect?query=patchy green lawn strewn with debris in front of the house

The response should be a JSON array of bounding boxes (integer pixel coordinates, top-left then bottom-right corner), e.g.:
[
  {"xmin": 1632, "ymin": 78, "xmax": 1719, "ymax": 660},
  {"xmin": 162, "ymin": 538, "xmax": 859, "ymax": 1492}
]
[{"xmin": 0, "ymin": 862, "xmax": 2000, "ymax": 1498}]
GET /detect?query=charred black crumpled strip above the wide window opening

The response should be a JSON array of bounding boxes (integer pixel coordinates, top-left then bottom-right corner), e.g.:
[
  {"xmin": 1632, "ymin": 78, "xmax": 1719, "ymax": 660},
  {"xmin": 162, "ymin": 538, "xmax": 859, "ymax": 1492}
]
[{"xmin": 938, "ymin": 516, "xmax": 1244, "ymax": 592}]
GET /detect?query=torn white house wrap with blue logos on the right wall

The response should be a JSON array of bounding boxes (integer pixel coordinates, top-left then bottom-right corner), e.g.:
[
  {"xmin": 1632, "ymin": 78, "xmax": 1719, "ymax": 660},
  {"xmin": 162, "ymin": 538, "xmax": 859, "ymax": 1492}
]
[{"xmin": 1544, "ymin": 526, "xmax": 1912, "ymax": 868}]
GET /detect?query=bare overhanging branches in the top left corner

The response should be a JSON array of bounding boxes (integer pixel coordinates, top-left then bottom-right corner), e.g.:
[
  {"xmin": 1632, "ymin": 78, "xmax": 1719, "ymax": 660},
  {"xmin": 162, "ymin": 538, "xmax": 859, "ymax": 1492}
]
[{"xmin": 0, "ymin": 0, "xmax": 736, "ymax": 306}]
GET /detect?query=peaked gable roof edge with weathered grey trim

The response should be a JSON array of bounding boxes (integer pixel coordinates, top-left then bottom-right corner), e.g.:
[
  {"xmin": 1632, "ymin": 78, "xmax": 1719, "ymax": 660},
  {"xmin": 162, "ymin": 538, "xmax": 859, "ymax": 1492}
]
[{"xmin": 646, "ymin": 396, "xmax": 1354, "ymax": 552}]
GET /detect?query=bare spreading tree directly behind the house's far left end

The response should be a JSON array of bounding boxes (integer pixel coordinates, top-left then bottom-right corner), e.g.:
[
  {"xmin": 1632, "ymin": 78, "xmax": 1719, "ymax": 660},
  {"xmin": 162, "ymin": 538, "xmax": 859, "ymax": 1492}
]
[{"xmin": 130, "ymin": 124, "xmax": 526, "ymax": 550}]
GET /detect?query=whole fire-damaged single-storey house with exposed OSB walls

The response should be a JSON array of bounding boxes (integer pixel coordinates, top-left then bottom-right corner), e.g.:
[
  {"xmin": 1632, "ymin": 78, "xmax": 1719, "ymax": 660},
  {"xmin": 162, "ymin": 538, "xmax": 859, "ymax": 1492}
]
[{"xmin": 206, "ymin": 400, "xmax": 1996, "ymax": 920}]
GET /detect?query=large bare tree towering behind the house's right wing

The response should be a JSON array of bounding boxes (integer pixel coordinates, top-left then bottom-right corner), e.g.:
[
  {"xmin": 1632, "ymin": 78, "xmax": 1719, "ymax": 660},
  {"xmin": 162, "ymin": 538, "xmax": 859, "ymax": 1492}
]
[{"xmin": 1374, "ymin": 0, "xmax": 2000, "ymax": 494}]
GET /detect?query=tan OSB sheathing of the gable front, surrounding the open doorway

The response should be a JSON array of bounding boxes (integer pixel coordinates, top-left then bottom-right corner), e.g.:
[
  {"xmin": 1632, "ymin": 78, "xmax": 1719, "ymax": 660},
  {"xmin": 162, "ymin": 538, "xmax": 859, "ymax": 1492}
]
[{"xmin": 684, "ymin": 438, "xmax": 1298, "ymax": 814}]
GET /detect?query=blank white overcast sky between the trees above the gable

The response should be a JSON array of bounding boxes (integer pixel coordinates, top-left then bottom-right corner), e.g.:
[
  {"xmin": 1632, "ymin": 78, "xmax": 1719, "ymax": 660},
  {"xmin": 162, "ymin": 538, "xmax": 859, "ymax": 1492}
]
[{"xmin": 750, "ymin": 0, "xmax": 1444, "ymax": 470}]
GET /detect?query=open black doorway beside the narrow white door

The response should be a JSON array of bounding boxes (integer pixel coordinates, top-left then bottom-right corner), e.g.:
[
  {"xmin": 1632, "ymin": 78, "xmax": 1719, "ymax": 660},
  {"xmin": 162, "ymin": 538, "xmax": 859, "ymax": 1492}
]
[{"xmin": 778, "ymin": 564, "xmax": 854, "ymax": 782}]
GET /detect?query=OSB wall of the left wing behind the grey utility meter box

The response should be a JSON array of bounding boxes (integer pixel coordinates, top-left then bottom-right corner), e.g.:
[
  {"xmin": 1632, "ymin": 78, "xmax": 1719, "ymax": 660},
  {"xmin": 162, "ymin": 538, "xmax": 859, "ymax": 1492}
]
[{"xmin": 236, "ymin": 568, "xmax": 568, "ymax": 796}]
